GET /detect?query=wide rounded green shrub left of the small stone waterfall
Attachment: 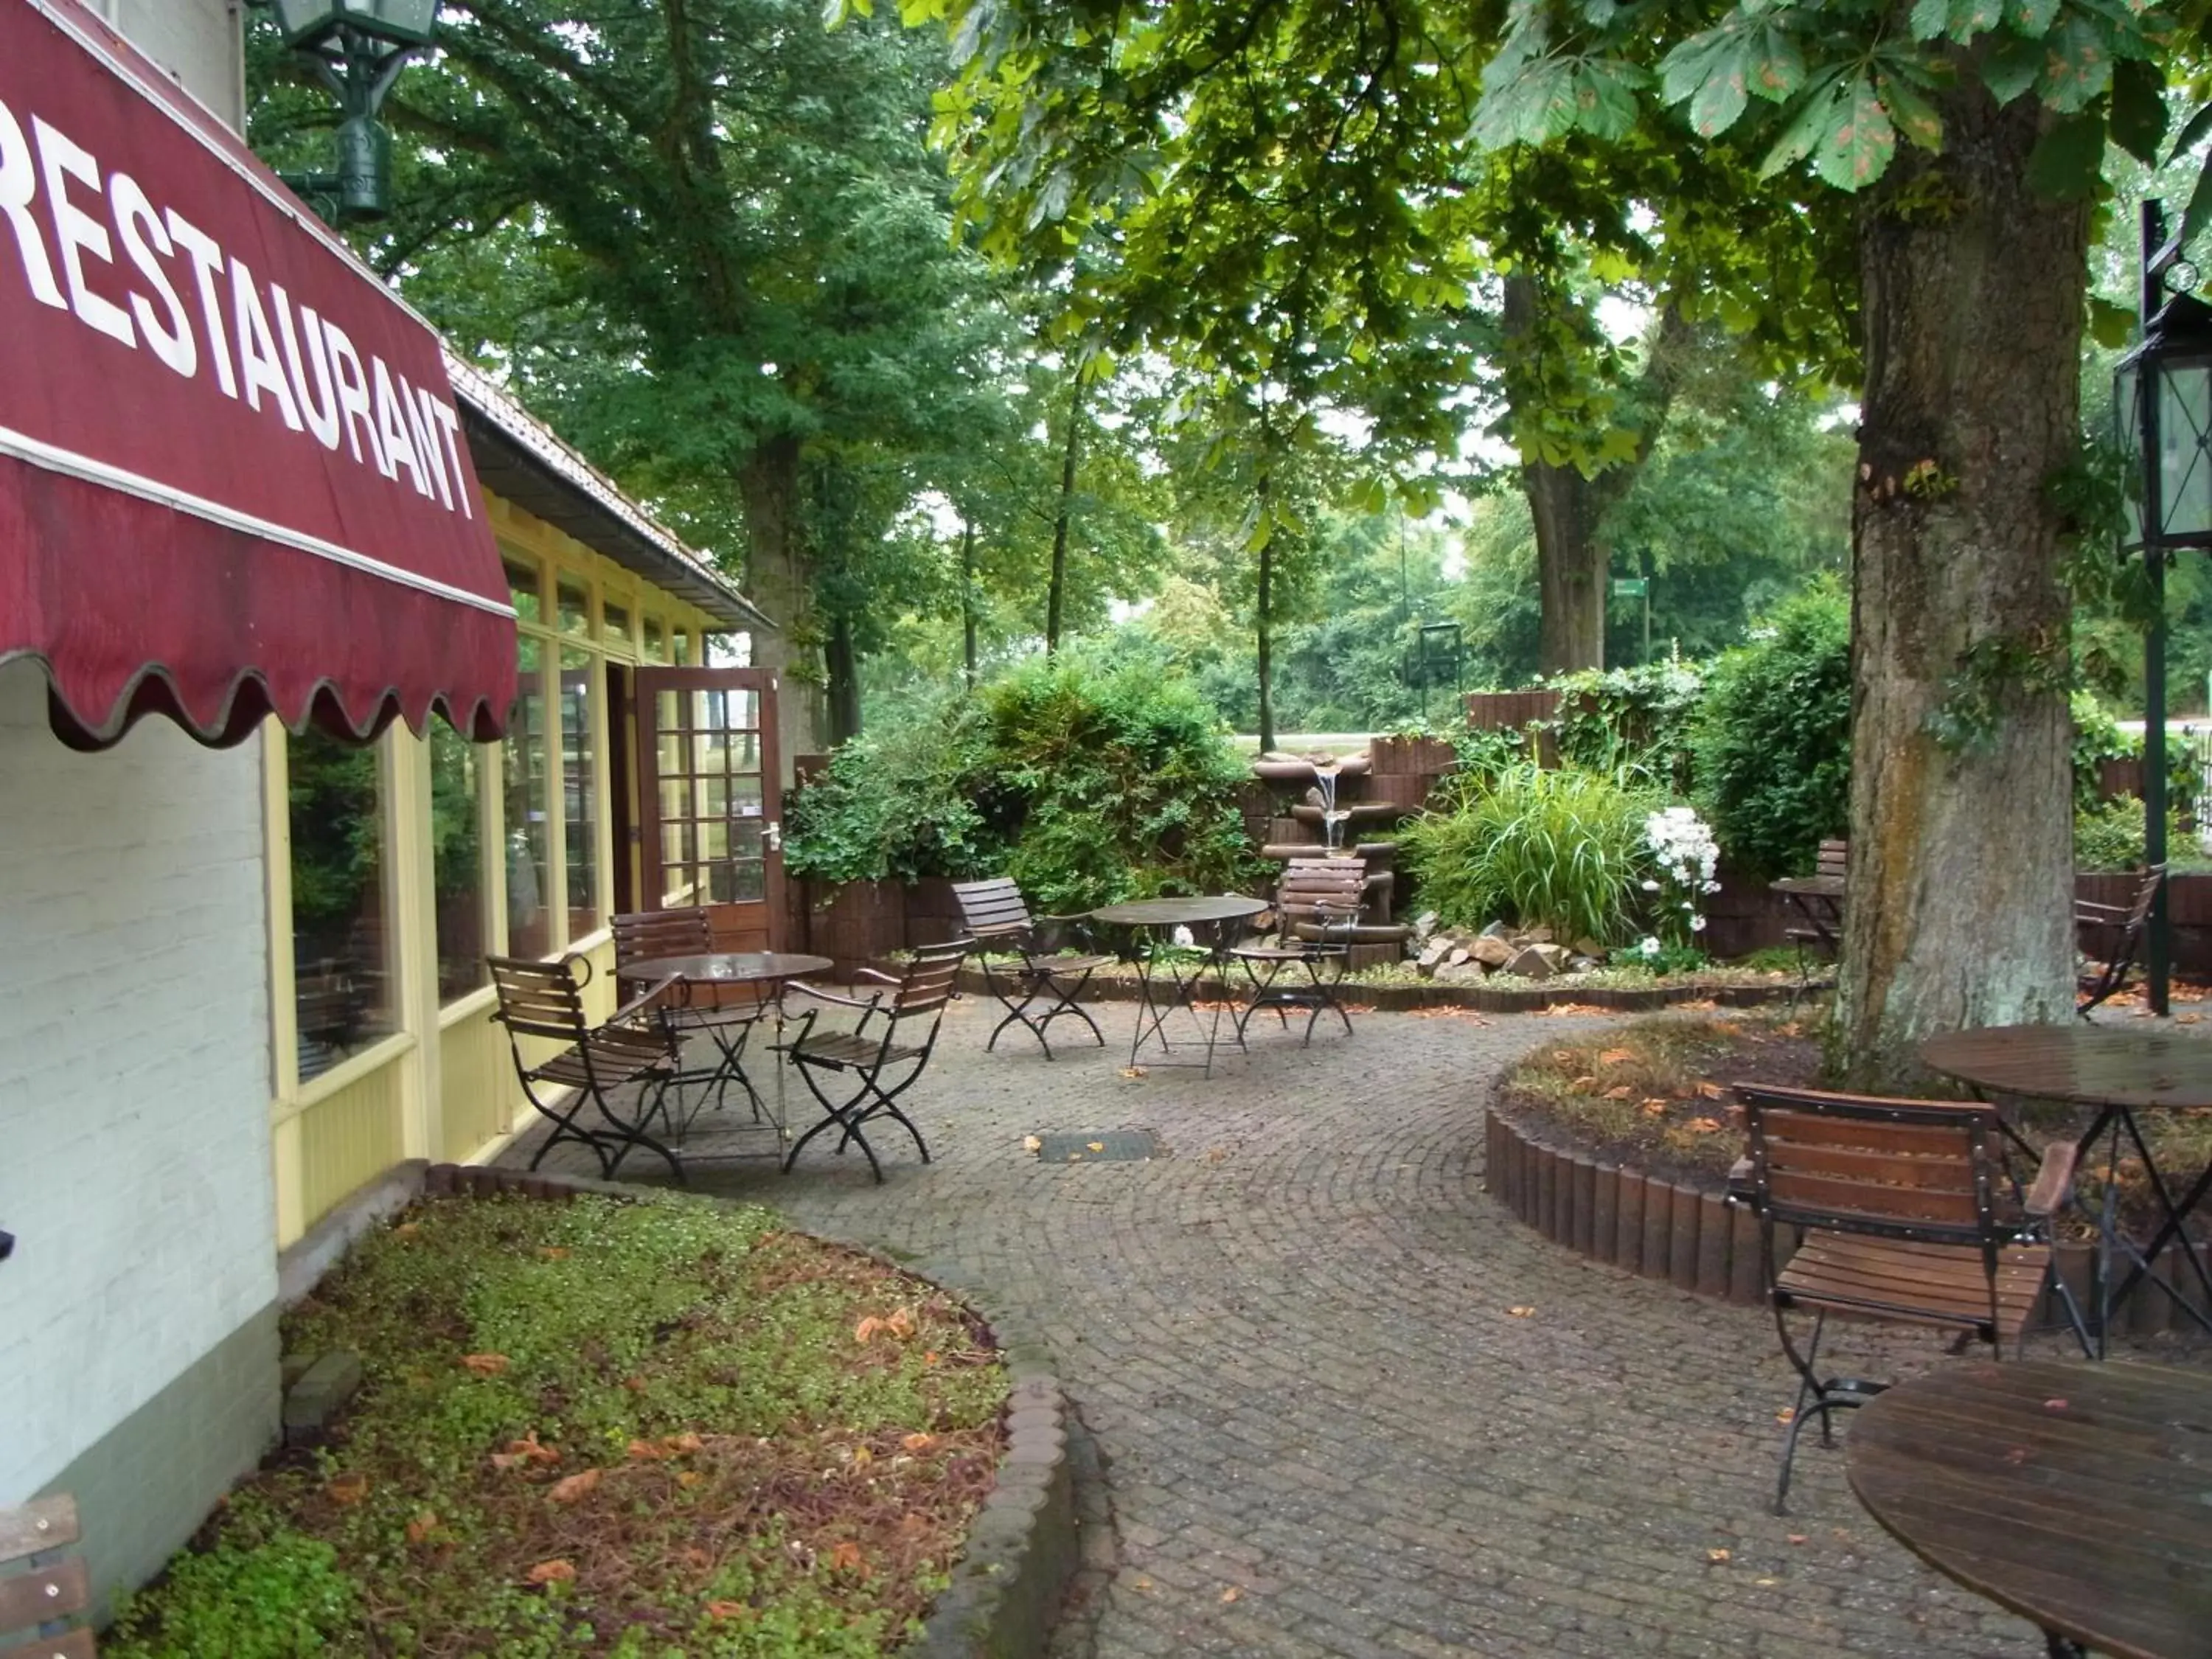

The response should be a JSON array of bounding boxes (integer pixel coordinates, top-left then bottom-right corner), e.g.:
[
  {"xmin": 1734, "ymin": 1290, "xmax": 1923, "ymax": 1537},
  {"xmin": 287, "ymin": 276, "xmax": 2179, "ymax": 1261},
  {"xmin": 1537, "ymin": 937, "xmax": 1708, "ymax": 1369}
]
[{"xmin": 787, "ymin": 655, "xmax": 1252, "ymax": 911}]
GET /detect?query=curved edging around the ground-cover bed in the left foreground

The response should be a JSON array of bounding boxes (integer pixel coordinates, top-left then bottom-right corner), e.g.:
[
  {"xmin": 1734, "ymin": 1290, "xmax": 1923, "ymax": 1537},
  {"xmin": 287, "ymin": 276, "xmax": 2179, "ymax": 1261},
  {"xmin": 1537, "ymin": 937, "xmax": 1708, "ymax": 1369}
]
[{"xmin": 422, "ymin": 1164, "xmax": 1077, "ymax": 1659}]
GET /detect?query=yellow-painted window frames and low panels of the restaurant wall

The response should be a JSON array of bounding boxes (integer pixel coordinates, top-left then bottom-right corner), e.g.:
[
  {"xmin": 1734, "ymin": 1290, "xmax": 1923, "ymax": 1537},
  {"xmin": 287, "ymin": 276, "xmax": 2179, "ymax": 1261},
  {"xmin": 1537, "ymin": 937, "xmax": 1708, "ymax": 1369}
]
[{"xmin": 263, "ymin": 484, "xmax": 717, "ymax": 1248}]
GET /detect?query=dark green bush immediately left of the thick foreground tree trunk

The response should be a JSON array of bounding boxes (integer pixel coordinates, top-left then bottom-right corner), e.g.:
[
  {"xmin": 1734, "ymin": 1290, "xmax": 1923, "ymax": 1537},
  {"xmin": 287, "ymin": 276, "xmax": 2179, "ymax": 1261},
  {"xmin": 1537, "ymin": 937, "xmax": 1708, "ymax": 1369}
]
[{"xmin": 1692, "ymin": 582, "xmax": 1851, "ymax": 876}]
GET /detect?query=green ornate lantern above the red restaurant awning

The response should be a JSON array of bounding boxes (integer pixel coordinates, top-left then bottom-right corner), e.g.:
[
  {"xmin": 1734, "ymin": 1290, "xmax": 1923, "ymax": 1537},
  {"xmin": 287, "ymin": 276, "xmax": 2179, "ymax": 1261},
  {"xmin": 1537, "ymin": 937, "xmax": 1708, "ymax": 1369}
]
[{"xmin": 265, "ymin": 0, "xmax": 438, "ymax": 219}]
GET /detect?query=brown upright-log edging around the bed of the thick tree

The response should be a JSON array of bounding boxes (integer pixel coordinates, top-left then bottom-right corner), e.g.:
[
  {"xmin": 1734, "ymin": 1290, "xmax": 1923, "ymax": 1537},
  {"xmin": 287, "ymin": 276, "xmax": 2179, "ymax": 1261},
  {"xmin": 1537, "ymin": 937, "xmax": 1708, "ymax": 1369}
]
[{"xmin": 1482, "ymin": 1106, "xmax": 2174, "ymax": 1336}]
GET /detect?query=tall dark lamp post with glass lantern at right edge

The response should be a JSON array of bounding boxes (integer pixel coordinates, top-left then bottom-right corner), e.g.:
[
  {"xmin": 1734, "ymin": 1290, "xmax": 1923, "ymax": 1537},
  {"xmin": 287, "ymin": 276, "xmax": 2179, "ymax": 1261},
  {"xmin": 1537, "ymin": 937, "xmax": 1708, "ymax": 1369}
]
[{"xmin": 2112, "ymin": 201, "xmax": 2212, "ymax": 1015}]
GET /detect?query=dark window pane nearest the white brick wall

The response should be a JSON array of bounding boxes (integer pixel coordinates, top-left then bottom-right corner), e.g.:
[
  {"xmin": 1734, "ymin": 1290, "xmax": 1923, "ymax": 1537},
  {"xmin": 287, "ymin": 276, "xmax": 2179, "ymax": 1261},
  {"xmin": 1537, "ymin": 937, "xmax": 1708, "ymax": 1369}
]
[{"xmin": 288, "ymin": 732, "xmax": 398, "ymax": 1082}]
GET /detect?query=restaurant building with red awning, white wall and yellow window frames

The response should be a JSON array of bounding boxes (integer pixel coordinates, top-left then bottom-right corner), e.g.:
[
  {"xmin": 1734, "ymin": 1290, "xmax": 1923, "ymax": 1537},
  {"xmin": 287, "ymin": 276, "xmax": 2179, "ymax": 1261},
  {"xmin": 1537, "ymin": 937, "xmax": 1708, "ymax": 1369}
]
[{"xmin": 0, "ymin": 0, "xmax": 781, "ymax": 1599}]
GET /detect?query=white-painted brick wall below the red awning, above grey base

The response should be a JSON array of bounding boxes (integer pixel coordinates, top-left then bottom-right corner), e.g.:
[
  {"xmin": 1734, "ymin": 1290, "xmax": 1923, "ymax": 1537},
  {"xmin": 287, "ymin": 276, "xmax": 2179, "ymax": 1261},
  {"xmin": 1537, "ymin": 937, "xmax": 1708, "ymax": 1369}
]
[{"xmin": 0, "ymin": 661, "xmax": 276, "ymax": 1506}]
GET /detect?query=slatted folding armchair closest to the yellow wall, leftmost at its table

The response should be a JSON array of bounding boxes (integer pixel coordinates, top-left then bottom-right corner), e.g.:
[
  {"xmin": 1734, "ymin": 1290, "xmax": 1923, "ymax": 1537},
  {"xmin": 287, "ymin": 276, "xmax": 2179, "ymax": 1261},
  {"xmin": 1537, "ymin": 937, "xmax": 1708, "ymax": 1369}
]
[{"xmin": 484, "ymin": 956, "xmax": 684, "ymax": 1181}]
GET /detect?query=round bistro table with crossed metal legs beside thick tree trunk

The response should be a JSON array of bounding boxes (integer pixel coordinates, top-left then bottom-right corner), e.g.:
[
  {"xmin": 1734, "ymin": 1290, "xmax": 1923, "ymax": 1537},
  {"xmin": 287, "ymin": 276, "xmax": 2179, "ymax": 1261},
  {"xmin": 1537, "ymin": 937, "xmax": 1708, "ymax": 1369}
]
[{"xmin": 1920, "ymin": 1022, "xmax": 2212, "ymax": 1349}]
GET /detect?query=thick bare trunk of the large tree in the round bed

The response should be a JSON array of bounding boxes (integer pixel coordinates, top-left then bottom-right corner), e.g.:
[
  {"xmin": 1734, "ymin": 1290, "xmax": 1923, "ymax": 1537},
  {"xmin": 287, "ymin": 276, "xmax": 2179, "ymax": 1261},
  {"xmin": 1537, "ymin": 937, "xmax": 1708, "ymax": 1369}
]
[{"xmin": 1834, "ymin": 84, "xmax": 2088, "ymax": 1088}]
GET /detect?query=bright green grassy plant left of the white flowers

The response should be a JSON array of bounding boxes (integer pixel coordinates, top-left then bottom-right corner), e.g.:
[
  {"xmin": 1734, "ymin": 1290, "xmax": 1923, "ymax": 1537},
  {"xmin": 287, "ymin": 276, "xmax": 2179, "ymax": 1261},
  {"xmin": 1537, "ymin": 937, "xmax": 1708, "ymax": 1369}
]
[{"xmin": 1402, "ymin": 761, "xmax": 1661, "ymax": 945}]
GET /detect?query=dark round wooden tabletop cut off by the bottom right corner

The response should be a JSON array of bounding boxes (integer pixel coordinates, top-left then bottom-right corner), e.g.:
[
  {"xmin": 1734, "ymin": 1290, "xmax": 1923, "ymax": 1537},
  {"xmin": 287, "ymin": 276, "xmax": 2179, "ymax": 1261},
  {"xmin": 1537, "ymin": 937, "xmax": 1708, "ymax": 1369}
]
[{"xmin": 1843, "ymin": 1363, "xmax": 2212, "ymax": 1659}]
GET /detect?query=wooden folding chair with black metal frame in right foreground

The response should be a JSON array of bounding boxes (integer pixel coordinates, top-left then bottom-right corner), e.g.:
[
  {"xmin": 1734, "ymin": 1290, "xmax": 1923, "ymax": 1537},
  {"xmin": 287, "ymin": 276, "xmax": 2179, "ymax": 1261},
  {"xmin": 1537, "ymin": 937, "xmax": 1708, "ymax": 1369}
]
[{"xmin": 1736, "ymin": 1084, "xmax": 2088, "ymax": 1515}]
